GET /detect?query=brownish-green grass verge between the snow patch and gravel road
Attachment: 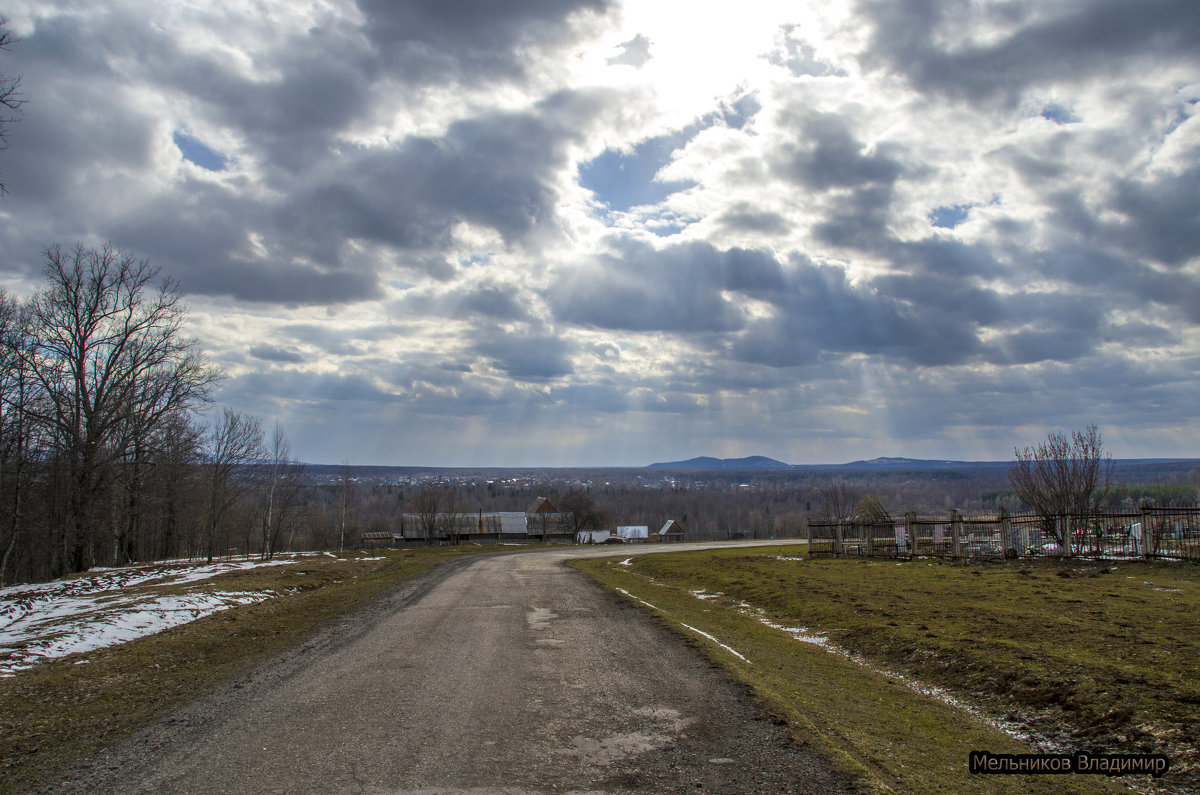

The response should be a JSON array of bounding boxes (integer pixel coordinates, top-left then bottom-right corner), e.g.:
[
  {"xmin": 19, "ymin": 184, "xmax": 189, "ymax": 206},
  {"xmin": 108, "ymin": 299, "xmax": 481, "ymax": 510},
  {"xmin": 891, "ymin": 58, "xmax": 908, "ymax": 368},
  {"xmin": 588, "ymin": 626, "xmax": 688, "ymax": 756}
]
[{"xmin": 0, "ymin": 546, "xmax": 500, "ymax": 793}]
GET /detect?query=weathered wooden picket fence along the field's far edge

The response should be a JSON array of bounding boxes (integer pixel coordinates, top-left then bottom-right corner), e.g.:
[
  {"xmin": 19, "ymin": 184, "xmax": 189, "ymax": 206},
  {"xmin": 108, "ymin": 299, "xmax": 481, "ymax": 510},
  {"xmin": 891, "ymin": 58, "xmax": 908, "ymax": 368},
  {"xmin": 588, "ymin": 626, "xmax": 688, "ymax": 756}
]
[{"xmin": 806, "ymin": 506, "xmax": 1200, "ymax": 561}]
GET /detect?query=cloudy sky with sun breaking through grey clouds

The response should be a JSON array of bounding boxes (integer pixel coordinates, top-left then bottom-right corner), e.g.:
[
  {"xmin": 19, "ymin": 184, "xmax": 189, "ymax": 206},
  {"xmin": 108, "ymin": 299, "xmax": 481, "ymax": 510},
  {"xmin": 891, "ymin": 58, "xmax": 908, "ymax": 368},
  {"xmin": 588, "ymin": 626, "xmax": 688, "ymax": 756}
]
[{"xmin": 0, "ymin": 0, "xmax": 1200, "ymax": 467}]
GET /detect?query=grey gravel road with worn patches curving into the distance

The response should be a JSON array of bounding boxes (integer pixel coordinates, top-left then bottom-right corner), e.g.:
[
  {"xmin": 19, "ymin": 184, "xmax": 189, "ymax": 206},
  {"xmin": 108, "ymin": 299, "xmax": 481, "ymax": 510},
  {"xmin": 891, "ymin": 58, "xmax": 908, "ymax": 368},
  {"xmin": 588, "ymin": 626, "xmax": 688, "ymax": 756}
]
[{"xmin": 44, "ymin": 545, "xmax": 853, "ymax": 795}]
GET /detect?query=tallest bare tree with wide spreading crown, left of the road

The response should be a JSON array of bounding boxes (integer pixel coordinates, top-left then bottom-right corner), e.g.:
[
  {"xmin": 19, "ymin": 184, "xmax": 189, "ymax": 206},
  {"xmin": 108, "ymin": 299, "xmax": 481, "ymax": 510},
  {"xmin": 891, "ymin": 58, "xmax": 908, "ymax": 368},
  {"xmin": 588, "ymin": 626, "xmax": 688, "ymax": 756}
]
[{"xmin": 24, "ymin": 244, "xmax": 218, "ymax": 572}]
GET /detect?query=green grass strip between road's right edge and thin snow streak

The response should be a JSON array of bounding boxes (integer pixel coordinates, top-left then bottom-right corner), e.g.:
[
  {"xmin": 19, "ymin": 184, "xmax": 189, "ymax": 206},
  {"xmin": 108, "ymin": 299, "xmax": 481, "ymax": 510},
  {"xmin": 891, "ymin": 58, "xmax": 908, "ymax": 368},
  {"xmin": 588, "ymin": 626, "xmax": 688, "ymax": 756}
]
[{"xmin": 571, "ymin": 548, "xmax": 1124, "ymax": 793}]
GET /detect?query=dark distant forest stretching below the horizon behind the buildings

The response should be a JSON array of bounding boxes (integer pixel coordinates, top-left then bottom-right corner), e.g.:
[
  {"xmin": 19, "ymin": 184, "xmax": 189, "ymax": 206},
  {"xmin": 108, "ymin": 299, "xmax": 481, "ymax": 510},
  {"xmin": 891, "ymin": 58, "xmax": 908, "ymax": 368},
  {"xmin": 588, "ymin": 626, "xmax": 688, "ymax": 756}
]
[{"xmin": 0, "ymin": 451, "xmax": 1200, "ymax": 582}]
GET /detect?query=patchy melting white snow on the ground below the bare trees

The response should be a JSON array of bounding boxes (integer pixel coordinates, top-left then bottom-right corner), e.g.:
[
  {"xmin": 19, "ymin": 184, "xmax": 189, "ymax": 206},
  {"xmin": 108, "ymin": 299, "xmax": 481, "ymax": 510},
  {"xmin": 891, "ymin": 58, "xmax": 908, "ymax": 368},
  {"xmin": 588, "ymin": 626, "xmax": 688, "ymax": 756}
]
[{"xmin": 0, "ymin": 560, "xmax": 300, "ymax": 676}]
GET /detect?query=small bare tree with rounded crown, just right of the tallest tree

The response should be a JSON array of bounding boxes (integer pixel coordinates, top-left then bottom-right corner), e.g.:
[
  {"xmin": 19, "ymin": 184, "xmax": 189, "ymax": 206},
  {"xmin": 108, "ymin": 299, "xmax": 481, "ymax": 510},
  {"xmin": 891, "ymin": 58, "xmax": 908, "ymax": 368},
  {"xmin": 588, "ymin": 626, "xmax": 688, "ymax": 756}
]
[{"xmin": 204, "ymin": 408, "xmax": 263, "ymax": 563}]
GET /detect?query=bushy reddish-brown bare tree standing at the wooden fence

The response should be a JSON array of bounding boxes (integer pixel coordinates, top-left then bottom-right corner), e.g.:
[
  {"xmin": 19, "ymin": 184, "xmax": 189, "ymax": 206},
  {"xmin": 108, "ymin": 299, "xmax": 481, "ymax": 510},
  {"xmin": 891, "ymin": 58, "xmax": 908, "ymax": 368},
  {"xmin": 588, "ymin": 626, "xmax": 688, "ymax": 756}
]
[{"xmin": 1008, "ymin": 425, "xmax": 1112, "ymax": 549}]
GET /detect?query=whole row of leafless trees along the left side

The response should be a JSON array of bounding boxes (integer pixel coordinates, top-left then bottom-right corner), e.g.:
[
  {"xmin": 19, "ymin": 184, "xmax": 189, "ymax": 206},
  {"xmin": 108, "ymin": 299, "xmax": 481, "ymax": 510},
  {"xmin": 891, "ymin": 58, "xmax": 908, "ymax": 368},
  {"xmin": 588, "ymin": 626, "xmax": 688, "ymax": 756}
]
[{"xmin": 0, "ymin": 245, "xmax": 321, "ymax": 582}]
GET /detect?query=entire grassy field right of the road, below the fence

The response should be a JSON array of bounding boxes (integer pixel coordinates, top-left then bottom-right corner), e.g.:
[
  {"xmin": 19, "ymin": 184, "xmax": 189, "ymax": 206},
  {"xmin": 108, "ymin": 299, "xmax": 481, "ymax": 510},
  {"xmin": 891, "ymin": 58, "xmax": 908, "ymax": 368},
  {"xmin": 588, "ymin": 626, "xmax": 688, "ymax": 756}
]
[{"xmin": 575, "ymin": 546, "xmax": 1200, "ymax": 793}]
